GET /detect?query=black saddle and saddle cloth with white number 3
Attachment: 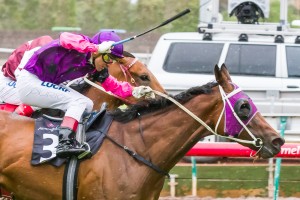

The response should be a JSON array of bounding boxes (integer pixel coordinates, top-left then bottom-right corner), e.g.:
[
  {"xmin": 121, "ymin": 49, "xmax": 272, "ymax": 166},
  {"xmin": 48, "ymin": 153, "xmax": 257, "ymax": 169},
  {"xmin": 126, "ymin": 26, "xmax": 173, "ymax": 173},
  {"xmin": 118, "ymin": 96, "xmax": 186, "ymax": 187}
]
[{"xmin": 31, "ymin": 106, "xmax": 112, "ymax": 167}]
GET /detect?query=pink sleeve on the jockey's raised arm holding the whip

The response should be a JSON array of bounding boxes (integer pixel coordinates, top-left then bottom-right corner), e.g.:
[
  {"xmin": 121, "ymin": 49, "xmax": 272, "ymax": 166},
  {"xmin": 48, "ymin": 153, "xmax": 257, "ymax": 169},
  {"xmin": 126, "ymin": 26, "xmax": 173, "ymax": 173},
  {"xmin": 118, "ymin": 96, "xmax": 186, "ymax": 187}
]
[{"xmin": 59, "ymin": 32, "xmax": 98, "ymax": 53}]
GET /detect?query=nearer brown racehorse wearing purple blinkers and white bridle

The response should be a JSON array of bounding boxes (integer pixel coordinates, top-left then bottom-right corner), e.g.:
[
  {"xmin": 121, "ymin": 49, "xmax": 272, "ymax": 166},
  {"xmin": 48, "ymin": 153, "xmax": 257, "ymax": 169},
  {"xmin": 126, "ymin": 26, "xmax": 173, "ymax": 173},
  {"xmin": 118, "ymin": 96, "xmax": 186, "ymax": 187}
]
[{"xmin": 0, "ymin": 65, "xmax": 284, "ymax": 200}]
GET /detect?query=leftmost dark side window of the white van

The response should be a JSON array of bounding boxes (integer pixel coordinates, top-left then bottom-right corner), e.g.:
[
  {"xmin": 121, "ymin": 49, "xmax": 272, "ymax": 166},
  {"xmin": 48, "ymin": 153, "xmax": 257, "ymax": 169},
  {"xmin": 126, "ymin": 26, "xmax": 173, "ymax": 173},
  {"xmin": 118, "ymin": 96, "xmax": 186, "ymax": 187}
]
[{"xmin": 163, "ymin": 43, "xmax": 224, "ymax": 74}]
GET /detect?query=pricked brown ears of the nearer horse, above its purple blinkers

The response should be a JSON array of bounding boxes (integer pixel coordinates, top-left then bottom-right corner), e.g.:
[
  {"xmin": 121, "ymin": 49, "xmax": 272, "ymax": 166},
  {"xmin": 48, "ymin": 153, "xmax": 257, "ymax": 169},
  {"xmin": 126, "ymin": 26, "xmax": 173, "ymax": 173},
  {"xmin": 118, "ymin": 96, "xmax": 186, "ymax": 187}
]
[{"xmin": 215, "ymin": 63, "xmax": 233, "ymax": 92}]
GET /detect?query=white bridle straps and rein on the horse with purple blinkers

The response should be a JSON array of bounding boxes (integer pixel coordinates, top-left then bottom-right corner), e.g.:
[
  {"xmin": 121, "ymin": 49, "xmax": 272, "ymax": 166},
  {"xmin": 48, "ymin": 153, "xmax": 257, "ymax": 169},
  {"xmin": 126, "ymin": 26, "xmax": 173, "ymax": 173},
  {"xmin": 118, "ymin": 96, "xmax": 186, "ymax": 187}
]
[{"xmin": 153, "ymin": 86, "xmax": 263, "ymax": 152}]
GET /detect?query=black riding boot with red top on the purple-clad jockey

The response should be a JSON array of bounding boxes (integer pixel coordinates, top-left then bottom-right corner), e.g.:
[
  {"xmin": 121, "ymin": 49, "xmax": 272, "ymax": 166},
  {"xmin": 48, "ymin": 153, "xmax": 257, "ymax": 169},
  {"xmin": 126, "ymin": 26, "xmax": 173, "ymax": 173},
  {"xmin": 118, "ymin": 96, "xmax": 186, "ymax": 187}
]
[{"xmin": 56, "ymin": 116, "xmax": 85, "ymax": 158}]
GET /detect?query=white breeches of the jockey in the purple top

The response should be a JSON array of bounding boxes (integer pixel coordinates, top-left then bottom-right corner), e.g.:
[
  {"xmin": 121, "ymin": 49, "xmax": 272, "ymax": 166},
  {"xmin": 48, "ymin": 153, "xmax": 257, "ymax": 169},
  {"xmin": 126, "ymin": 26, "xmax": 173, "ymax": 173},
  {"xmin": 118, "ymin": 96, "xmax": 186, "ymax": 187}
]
[{"xmin": 16, "ymin": 70, "xmax": 93, "ymax": 121}]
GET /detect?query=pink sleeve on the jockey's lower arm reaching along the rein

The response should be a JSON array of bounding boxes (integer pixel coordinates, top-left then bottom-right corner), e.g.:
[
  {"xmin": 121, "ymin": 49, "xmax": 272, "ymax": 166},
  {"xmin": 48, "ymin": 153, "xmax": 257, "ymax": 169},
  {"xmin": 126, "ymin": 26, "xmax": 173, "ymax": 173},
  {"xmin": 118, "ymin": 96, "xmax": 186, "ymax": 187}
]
[{"xmin": 101, "ymin": 75, "xmax": 133, "ymax": 98}]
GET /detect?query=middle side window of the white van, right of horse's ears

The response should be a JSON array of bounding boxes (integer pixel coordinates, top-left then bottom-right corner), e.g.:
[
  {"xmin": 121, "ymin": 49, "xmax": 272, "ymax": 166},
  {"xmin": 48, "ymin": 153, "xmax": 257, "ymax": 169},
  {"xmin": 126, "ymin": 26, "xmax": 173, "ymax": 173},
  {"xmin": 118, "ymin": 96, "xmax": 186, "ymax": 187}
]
[{"xmin": 225, "ymin": 44, "xmax": 276, "ymax": 77}]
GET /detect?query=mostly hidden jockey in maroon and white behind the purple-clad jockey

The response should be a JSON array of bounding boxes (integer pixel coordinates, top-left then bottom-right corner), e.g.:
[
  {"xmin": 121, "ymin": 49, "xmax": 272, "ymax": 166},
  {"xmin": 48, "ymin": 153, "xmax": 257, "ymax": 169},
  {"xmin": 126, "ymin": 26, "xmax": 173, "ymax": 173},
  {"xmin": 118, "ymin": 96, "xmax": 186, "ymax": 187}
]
[{"xmin": 0, "ymin": 36, "xmax": 53, "ymax": 117}]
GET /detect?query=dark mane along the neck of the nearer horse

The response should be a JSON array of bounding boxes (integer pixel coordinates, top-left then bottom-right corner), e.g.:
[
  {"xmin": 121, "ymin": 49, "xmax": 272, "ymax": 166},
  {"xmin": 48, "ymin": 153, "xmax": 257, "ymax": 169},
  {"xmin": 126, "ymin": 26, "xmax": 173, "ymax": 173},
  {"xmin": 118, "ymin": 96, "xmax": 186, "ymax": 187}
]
[{"xmin": 110, "ymin": 81, "xmax": 218, "ymax": 123}]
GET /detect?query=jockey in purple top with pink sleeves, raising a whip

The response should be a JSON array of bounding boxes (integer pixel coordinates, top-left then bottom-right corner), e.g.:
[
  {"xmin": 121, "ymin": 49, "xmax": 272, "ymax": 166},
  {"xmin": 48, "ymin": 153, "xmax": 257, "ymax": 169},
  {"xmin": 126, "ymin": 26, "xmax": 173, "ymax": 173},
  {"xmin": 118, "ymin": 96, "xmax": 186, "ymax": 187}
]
[{"xmin": 15, "ymin": 31, "xmax": 151, "ymax": 157}]
